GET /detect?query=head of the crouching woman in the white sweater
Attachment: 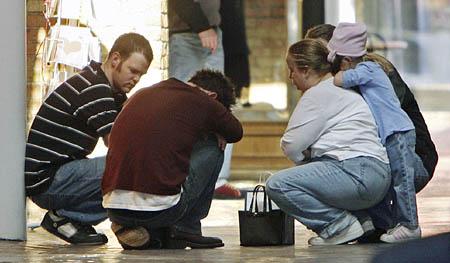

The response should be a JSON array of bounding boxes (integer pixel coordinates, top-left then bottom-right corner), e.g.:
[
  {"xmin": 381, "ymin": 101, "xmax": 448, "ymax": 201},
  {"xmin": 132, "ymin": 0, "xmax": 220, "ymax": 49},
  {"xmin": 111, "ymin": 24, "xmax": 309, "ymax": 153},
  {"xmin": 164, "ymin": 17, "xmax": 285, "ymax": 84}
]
[{"xmin": 286, "ymin": 39, "xmax": 331, "ymax": 91}]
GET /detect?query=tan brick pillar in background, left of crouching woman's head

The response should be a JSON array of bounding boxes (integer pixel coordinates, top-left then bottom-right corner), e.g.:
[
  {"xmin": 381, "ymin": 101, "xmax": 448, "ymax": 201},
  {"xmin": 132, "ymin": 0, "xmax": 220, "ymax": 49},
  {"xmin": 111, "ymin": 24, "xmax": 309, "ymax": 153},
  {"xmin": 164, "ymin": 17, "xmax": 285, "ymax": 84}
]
[{"xmin": 245, "ymin": 0, "xmax": 287, "ymax": 83}]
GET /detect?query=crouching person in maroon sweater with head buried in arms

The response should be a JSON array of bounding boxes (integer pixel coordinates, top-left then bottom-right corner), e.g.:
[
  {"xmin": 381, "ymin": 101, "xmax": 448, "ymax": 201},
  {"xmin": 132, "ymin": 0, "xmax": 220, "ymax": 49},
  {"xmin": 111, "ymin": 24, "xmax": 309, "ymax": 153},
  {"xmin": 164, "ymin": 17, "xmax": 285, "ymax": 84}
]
[{"xmin": 102, "ymin": 70, "xmax": 242, "ymax": 249}]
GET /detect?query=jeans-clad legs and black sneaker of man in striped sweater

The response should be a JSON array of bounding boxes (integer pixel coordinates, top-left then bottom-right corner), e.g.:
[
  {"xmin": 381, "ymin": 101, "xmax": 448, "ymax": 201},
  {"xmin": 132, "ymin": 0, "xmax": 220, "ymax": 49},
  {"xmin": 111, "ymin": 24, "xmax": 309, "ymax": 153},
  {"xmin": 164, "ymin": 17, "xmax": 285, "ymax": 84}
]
[{"xmin": 31, "ymin": 157, "xmax": 107, "ymax": 244}]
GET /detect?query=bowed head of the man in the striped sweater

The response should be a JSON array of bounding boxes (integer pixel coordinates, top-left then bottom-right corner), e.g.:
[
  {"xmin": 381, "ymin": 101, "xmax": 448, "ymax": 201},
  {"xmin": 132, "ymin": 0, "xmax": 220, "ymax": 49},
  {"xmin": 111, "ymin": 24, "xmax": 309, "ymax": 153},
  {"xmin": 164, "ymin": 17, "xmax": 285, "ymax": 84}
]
[{"xmin": 105, "ymin": 33, "xmax": 153, "ymax": 93}]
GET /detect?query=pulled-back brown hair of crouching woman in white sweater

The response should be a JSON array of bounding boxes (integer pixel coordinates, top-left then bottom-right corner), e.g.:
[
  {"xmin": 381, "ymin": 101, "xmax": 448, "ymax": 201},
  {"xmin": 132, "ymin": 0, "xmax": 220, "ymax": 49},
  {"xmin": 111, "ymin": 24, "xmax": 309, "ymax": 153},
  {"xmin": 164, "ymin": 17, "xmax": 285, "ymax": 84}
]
[{"xmin": 288, "ymin": 39, "xmax": 331, "ymax": 75}]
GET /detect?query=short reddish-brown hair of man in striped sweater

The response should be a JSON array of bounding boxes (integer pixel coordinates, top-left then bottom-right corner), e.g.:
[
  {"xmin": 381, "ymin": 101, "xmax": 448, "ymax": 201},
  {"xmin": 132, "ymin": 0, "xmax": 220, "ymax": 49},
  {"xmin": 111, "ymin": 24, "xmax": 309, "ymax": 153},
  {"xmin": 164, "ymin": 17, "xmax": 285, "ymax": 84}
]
[{"xmin": 108, "ymin": 33, "xmax": 153, "ymax": 64}]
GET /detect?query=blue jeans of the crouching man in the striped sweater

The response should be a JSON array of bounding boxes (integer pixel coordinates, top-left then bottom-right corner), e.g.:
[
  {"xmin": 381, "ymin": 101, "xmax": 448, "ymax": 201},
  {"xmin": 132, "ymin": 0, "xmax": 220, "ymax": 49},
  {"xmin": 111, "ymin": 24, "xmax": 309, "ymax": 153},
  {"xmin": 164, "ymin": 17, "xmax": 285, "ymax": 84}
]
[{"xmin": 31, "ymin": 156, "xmax": 107, "ymax": 225}]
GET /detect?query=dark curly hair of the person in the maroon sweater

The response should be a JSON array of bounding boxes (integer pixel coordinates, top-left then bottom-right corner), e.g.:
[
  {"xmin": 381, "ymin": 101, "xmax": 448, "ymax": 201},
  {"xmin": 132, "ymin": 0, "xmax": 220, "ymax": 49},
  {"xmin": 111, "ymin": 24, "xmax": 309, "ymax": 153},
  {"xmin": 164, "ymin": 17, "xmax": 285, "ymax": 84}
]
[{"xmin": 189, "ymin": 69, "xmax": 236, "ymax": 109}]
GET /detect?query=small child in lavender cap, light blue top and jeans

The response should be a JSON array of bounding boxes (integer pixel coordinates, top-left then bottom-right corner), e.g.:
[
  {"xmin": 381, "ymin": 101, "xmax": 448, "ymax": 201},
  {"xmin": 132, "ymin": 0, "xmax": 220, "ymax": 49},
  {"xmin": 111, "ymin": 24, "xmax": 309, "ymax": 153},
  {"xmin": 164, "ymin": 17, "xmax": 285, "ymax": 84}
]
[{"xmin": 327, "ymin": 23, "xmax": 429, "ymax": 243}]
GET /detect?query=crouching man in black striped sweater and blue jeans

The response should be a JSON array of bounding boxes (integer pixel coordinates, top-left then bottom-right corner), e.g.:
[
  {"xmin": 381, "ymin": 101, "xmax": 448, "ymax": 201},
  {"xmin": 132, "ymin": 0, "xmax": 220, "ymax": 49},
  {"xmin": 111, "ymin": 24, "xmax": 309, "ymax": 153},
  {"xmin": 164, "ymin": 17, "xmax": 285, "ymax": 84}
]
[{"xmin": 25, "ymin": 33, "xmax": 153, "ymax": 245}]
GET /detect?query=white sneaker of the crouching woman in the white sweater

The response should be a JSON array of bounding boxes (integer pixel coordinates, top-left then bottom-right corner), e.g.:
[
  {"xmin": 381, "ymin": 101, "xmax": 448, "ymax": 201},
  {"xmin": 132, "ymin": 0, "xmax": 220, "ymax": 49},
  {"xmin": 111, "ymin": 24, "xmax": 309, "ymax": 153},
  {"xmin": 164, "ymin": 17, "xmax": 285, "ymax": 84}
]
[{"xmin": 308, "ymin": 221, "xmax": 364, "ymax": 246}]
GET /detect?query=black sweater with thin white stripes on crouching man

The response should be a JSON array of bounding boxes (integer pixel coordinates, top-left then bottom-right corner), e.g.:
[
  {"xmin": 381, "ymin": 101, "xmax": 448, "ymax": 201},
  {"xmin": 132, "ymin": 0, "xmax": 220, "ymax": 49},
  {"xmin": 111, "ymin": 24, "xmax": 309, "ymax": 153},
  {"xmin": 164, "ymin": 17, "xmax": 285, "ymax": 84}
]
[{"xmin": 25, "ymin": 61, "xmax": 126, "ymax": 196}]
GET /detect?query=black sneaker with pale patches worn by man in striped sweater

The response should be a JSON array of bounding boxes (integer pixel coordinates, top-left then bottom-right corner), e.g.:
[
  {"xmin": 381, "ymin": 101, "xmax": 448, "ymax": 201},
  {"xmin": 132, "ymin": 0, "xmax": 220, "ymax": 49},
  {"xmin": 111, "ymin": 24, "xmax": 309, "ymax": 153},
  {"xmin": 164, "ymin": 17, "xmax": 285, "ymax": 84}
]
[{"xmin": 41, "ymin": 211, "xmax": 108, "ymax": 245}]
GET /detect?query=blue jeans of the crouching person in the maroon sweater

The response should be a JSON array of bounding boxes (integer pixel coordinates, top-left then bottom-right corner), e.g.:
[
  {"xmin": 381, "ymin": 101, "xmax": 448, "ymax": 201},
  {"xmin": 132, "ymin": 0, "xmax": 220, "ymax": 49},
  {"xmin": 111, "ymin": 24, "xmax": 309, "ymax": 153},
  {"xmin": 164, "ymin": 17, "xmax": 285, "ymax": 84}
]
[{"xmin": 107, "ymin": 136, "xmax": 223, "ymax": 234}]
